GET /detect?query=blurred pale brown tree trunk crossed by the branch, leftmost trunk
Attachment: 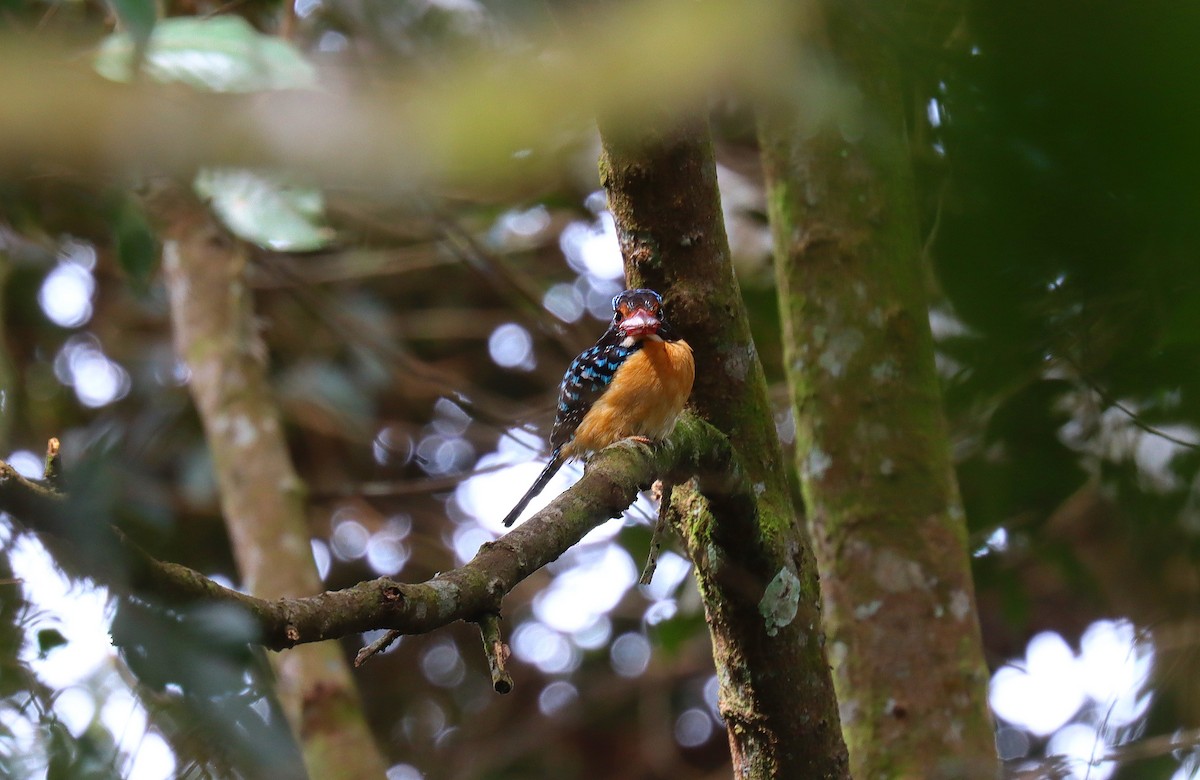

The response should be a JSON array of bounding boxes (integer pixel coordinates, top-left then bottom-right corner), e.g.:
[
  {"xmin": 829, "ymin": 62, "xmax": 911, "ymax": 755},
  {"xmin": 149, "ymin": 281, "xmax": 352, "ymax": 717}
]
[{"xmin": 152, "ymin": 186, "xmax": 385, "ymax": 778}]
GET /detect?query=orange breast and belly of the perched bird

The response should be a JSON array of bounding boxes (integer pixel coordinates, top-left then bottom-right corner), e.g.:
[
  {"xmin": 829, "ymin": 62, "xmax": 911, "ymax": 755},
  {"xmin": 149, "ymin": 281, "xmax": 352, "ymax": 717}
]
[{"xmin": 563, "ymin": 341, "xmax": 696, "ymax": 457}]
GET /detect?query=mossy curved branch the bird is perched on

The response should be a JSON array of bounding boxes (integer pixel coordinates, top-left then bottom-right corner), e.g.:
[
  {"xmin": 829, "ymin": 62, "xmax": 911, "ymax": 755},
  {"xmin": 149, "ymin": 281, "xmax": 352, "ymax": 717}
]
[{"xmin": 0, "ymin": 415, "xmax": 754, "ymax": 650}]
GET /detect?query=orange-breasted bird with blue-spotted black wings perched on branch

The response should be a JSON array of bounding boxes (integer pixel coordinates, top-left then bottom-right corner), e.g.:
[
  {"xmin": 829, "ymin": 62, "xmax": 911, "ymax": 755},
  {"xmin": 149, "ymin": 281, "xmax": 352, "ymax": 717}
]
[{"xmin": 504, "ymin": 289, "xmax": 696, "ymax": 526}]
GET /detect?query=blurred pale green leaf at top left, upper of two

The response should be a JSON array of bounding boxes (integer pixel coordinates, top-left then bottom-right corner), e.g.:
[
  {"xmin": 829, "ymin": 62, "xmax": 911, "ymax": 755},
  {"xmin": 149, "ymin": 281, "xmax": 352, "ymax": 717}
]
[{"xmin": 95, "ymin": 15, "xmax": 317, "ymax": 92}]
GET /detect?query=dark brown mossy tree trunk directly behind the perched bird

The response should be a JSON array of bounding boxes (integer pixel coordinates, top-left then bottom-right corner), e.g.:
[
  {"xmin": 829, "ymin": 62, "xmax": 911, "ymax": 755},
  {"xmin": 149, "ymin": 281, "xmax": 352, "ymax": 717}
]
[{"xmin": 600, "ymin": 116, "xmax": 847, "ymax": 778}]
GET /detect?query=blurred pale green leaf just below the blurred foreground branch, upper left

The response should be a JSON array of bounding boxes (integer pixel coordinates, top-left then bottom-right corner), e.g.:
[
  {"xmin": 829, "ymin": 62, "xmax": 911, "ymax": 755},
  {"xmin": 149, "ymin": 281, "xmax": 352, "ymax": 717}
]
[{"xmin": 193, "ymin": 168, "xmax": 334, "ymax": 252}]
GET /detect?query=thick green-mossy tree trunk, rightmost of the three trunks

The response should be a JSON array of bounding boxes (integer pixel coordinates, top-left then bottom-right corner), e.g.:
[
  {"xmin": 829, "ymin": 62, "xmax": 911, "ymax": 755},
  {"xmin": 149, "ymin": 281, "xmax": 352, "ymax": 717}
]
[{"xmin": 760, "ymin": 4, "xmax": 997, "ymax": 780}]
